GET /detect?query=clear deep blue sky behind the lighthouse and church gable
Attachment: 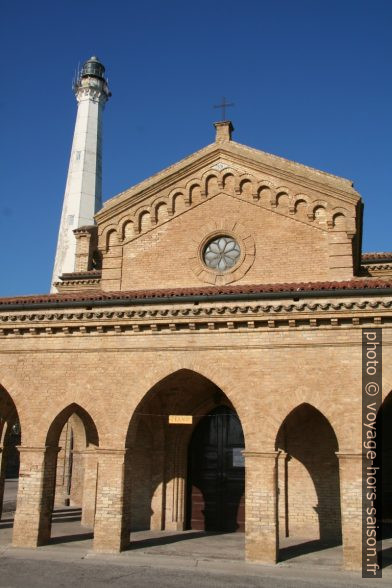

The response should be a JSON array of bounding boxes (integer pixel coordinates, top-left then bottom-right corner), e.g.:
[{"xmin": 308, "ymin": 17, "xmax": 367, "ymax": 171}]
[{"xmin": 0, "ymin": 0, "xmax": 392, "ymax": 296}]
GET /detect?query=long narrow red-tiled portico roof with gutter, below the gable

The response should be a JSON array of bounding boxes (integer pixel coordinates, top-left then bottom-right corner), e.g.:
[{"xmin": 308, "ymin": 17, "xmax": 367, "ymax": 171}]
[{"xmin": 0, "ymin": 278, "xmax": 392, "ymax": 311}]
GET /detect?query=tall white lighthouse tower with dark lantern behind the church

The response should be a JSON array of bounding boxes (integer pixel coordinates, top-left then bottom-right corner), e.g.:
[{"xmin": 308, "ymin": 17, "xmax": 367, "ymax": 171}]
[{"xmin": 51, "ymin": 57, "xmax": 111, "ymax": 292}]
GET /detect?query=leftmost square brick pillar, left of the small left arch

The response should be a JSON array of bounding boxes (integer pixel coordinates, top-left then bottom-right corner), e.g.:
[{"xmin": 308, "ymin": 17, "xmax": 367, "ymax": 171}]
[{"xmin": 12, "ymin": 446, "xmax": 59, "ymax": 547}]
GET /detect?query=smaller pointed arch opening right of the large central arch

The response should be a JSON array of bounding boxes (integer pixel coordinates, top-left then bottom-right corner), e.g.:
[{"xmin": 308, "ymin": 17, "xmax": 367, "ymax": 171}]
[{"xmin": 276, "ymin": 403, "xmax": 341, "ymax": 544}]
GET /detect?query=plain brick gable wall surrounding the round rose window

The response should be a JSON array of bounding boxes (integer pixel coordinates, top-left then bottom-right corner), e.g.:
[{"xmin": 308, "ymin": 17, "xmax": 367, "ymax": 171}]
[{"xmin": 119, "ymin": 195, "xmax": 330, "ymax": 290}]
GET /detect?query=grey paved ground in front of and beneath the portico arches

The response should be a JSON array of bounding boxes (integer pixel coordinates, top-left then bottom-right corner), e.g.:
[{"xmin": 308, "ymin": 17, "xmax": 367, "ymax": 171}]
[{"xmin": 0, "ymin": 482, "xmax": 392, "ymax": 588}]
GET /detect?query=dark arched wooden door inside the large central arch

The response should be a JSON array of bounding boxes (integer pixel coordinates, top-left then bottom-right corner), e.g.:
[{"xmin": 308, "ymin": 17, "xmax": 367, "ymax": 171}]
[{"xmin": 187, "ymin": 406, "xmax": 245, "ymax": 532}]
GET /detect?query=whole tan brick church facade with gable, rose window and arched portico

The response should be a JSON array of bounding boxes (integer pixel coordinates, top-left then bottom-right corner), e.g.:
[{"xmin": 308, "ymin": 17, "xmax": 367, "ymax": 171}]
[{"xmin": 0, "ymin": 122, "xmax": 392, "ymax": 569}]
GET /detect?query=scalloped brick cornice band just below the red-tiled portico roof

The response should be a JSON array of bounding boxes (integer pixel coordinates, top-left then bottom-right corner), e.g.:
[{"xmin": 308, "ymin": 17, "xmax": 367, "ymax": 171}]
[{"xmin": 0, "ymin": 298, "xmax": 392, "ymax": 337}]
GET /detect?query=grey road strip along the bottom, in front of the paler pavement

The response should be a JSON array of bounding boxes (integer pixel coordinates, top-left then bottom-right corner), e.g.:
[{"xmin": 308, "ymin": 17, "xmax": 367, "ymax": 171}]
[{"xmin": 0, "ymin": 558, "xmax": 391, "ymax": 588}]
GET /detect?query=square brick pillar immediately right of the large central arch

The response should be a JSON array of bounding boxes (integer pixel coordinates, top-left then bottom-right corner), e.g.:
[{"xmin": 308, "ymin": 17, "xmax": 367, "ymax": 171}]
[{"xmin": 244, "ymin": 451, "xmax": 279, "ymax": 564}]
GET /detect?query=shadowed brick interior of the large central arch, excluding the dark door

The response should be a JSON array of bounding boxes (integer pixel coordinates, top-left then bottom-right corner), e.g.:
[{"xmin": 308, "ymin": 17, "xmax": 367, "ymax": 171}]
[{"xmin": 126, "ymin": 369, "xmax": 242, "ymax": 530}]
